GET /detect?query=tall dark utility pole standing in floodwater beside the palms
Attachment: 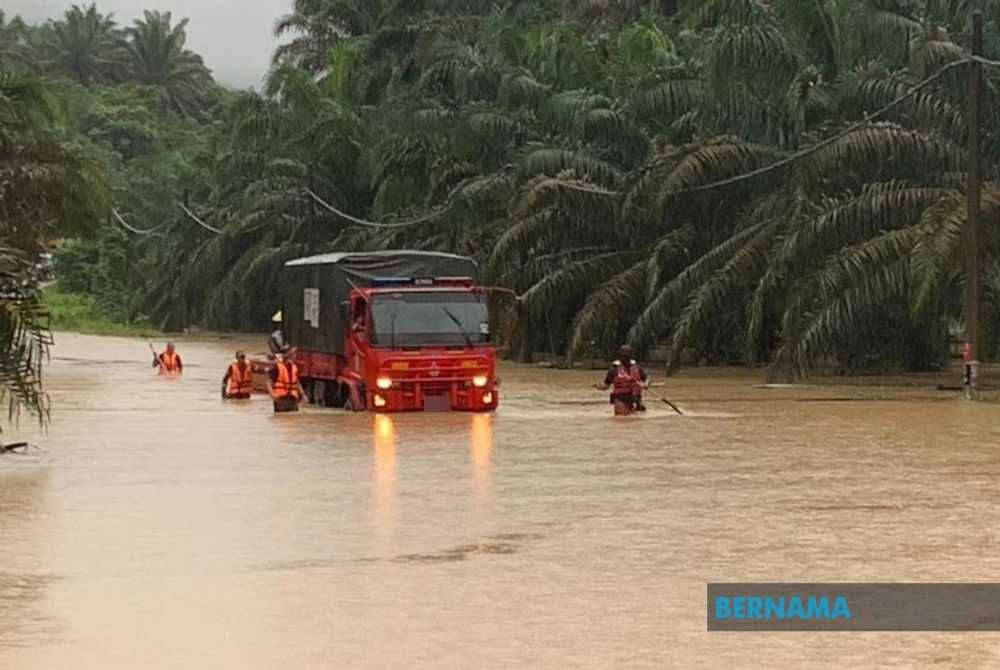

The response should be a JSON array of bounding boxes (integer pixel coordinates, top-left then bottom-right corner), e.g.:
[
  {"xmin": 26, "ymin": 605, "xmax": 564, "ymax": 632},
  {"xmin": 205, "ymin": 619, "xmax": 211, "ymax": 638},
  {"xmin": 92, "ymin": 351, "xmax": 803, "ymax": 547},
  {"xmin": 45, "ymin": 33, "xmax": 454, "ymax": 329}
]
[{"xmin": 965, "ymin": 11, "xmax": 983, "ymax": 400}]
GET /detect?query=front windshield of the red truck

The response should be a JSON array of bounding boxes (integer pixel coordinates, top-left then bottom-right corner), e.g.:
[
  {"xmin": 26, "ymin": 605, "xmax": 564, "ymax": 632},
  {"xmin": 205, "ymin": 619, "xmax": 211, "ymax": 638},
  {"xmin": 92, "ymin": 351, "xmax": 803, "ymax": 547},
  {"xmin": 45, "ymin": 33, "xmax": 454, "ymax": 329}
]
[{"xmin": 371, "ymin": 291, "xmax": 490, "ymax": 347}]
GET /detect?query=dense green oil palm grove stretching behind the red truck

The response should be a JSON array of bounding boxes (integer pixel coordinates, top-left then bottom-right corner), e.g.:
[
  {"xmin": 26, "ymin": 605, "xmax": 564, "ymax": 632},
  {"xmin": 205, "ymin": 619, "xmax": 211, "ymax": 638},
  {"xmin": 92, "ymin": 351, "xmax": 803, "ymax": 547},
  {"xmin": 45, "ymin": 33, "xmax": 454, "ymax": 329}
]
[{"xmin": 0, "ymin": 0, "xmax": 1000, "ymax": 394}]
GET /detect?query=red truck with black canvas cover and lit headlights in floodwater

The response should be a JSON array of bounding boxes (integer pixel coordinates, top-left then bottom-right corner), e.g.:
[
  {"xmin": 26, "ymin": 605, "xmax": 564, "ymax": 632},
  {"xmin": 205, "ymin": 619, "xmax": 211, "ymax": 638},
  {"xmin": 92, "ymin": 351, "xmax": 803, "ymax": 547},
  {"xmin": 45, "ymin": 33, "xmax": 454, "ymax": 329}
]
[{"xmin": 254, "ymin": 251, "xmax": 500, "ymax": 412}]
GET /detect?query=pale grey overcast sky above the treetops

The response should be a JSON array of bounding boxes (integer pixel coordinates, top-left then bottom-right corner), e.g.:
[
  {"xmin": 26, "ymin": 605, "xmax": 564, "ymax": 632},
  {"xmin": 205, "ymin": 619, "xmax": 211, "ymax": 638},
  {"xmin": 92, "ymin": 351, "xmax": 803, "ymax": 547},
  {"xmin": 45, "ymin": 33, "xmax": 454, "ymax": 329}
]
[{"xmin": 7, "ymin": 0, "xmax": 292, "ymax": 88}]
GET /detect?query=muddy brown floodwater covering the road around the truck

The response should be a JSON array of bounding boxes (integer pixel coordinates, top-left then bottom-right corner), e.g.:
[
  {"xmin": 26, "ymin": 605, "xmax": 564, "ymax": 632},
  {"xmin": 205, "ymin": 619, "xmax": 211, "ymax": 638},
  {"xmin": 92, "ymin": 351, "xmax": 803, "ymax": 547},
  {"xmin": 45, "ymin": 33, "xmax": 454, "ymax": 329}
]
[{"xmin": 0, "ymin": 334, "xmax": 1000, "ymax": 670}]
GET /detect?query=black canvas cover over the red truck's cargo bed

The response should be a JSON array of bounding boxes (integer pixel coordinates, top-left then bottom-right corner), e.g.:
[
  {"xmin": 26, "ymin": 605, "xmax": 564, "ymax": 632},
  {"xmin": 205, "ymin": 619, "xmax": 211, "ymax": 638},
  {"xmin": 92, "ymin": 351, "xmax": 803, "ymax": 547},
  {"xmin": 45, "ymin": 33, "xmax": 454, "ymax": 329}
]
[{"xmin": 282, "ymin": 251, "xmax": 476, "ymax": 354}]
